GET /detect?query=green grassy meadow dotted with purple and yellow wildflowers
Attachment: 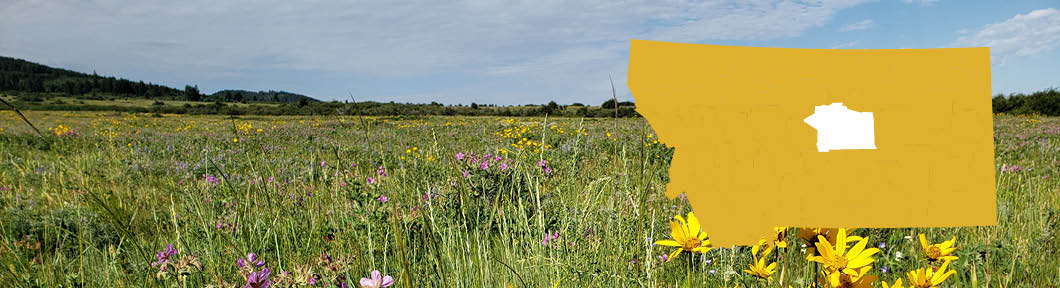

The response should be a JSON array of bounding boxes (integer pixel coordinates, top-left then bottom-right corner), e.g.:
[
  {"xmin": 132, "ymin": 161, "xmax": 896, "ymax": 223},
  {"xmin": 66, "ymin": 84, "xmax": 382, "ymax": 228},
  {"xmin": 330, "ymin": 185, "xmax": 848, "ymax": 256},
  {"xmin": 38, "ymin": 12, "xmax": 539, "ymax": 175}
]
[{"xmin": 0, "ymin": 110, "xmax": 1060, "ymax": 287}]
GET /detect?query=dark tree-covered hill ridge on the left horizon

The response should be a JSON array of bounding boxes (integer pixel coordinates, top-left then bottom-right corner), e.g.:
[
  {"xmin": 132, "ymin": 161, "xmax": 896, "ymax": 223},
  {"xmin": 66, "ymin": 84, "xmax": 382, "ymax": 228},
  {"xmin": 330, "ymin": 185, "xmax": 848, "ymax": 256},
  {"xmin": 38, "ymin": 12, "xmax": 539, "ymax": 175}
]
[{"xmin": 0, "ymin": 56, "xmax": 317, "ymax": 103}]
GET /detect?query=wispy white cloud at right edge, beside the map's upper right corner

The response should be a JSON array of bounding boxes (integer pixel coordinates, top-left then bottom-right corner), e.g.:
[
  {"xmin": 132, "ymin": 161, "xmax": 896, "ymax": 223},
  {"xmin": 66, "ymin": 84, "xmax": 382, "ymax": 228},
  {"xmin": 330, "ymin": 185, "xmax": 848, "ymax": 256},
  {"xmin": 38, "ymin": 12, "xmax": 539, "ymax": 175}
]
[{"xmin": 952, "ymin": 8, "xmax": 1060, "ymax": 62}]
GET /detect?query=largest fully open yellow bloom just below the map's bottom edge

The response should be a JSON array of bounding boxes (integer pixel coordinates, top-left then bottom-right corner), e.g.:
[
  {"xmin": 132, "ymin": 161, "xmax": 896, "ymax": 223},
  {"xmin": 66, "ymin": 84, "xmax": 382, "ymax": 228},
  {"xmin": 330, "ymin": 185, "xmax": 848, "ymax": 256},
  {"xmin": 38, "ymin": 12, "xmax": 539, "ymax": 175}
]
[{"xmin": 810, "ymin": 229, "xmax": 880, "ymax": 283}]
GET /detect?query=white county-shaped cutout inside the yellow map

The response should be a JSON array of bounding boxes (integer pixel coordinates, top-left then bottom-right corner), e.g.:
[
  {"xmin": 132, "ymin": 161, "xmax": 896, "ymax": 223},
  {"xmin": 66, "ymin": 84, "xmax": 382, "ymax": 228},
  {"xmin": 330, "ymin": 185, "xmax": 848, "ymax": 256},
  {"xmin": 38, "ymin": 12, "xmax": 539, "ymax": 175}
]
[{"xmin": 802, "ymin": 103, "xmax": 876, "ymax": 152}]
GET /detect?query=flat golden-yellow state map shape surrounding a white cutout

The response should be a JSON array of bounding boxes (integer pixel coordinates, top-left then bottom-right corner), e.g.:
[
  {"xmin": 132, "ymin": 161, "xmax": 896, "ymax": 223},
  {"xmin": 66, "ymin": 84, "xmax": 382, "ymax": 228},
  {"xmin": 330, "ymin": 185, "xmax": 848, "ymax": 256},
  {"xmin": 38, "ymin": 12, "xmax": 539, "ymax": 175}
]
[{"xmin": 629, "ymin": 40, "xmax": 996, "ymax": 247}]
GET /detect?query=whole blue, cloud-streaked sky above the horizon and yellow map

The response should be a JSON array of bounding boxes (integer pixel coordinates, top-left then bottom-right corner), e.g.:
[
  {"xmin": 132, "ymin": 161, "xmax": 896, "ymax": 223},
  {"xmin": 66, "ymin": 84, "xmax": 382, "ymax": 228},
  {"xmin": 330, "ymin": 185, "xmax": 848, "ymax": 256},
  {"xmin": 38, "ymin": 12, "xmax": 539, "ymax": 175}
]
[{"xmin": 0, "ymin": 0, "xmax": 1060, "ymax": 105}]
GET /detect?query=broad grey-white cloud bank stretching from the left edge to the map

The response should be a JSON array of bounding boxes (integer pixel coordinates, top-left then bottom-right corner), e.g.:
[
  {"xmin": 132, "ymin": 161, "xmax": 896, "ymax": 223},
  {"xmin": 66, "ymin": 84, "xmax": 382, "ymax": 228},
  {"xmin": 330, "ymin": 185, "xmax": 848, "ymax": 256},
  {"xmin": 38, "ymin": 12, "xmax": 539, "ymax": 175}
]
[{"xmin": 0, "ymin": 0, "xmax": 863, "ymax": 103}]
